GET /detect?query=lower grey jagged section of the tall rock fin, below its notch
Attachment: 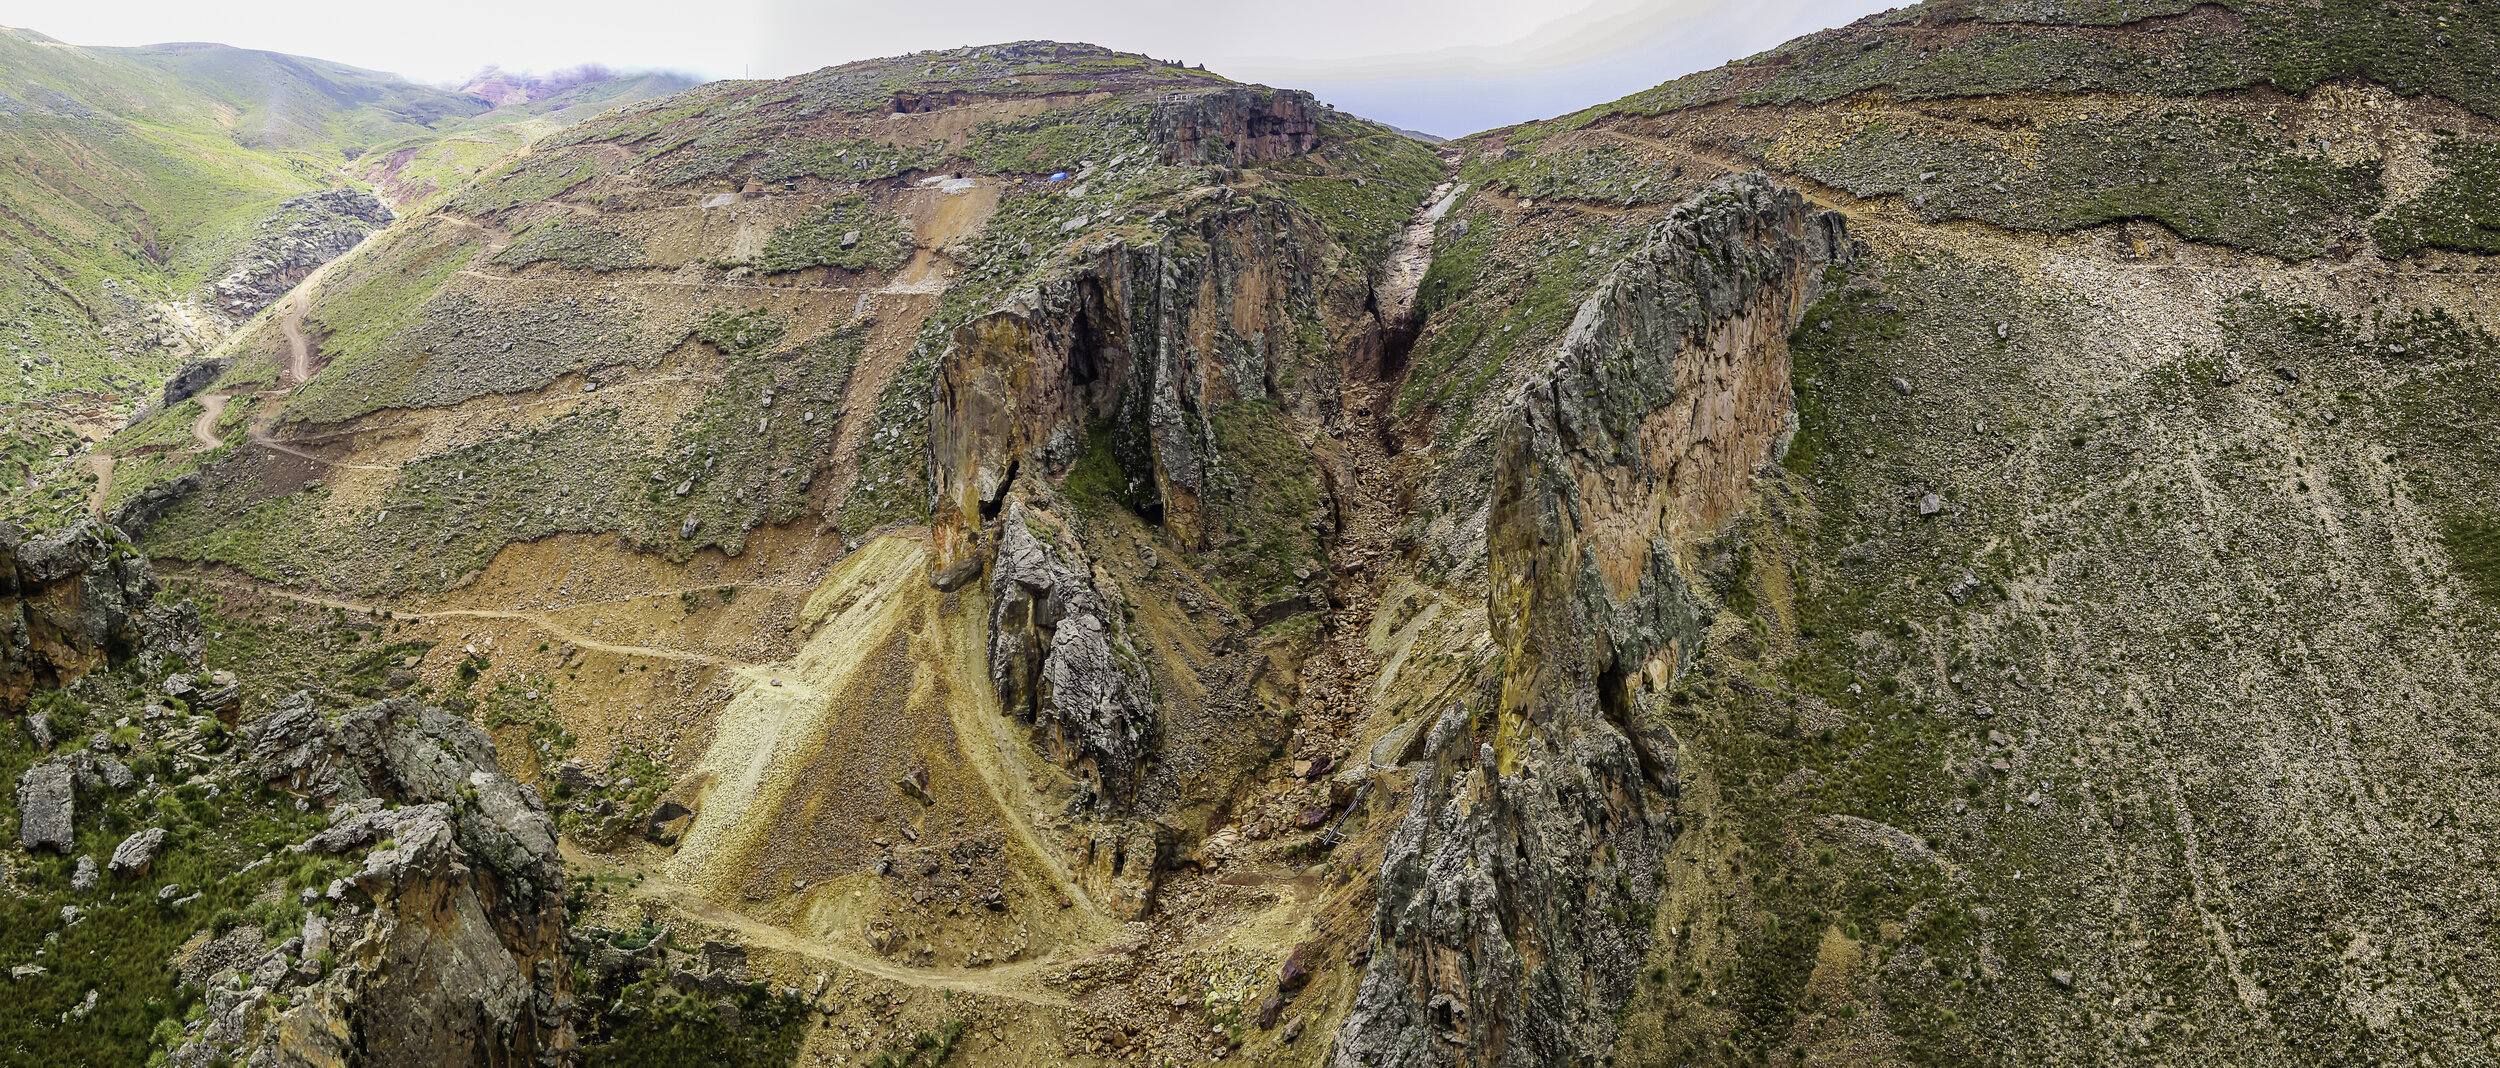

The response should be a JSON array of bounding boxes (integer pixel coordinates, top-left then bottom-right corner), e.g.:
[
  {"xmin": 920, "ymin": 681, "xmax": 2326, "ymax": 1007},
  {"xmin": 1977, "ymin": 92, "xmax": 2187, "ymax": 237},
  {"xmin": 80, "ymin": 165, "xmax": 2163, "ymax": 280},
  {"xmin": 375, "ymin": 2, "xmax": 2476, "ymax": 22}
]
[{"xmin": 1335, "ymin": 708, "xmax": 1673, "ymax": 1068}]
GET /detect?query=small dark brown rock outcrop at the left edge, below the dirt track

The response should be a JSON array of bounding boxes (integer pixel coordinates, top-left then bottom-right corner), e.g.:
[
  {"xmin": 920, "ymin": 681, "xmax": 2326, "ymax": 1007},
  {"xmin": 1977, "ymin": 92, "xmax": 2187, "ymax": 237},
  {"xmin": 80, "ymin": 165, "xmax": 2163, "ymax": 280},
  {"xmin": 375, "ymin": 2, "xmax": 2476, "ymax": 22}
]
[{"xmin": 0, "ymin": 520, "xmax": 200, "ymax": 710}]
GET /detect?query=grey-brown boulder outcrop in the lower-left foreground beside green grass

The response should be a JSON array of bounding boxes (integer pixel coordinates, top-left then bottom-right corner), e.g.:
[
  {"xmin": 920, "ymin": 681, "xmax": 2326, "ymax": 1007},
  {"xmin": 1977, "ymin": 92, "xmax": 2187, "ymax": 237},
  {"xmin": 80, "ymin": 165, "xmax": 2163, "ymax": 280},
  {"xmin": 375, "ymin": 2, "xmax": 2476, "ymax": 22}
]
[{"xmin": 175, "ymin": 695, "xmax": 573, "ymax": 1065}]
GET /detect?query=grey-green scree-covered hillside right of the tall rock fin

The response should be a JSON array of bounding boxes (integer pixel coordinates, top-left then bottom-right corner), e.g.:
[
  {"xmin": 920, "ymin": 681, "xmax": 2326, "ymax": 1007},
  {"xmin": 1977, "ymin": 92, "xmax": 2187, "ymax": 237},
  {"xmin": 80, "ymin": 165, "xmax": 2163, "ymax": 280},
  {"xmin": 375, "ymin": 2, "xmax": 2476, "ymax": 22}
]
[{"xmin": 1408, "ymin": 3, "xmax": 2495, "ymax": 1063}]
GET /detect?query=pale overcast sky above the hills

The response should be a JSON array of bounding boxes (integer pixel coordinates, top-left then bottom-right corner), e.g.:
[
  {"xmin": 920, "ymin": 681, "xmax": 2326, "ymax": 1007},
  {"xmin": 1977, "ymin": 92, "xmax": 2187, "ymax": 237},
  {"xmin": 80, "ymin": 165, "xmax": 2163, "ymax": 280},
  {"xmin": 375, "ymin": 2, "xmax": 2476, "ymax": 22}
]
[{"xmin": 0, "ymin": 0, "xmax": 1883, "ymax": 135}]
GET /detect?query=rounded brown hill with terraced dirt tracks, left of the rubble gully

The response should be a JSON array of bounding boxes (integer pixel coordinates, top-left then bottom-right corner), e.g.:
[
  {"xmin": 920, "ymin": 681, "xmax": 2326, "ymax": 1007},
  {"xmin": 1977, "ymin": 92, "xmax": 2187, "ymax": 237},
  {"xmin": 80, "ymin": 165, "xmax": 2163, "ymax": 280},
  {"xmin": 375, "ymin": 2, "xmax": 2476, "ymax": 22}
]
[{"xmin": 83, "ymin": 43, "xmax": 1445, "ymax": 1060}]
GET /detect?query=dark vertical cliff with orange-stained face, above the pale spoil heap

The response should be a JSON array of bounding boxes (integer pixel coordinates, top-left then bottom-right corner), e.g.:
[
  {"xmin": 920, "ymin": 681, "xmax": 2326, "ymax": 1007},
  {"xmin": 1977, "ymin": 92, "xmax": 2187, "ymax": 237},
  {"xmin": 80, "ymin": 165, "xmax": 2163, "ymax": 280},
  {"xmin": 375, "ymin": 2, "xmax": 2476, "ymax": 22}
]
[{"xmin": 930, "ymin": 188, "xmax": 1373, "ymax": 568}]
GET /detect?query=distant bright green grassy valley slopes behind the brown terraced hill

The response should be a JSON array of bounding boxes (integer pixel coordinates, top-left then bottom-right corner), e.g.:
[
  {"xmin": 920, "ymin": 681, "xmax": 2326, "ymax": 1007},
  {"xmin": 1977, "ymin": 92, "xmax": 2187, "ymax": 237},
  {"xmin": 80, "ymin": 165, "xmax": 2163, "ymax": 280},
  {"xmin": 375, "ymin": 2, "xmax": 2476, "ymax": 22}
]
[{"xmin": 0, "ymin": 30, "xmax": 683, "ymax": 415}]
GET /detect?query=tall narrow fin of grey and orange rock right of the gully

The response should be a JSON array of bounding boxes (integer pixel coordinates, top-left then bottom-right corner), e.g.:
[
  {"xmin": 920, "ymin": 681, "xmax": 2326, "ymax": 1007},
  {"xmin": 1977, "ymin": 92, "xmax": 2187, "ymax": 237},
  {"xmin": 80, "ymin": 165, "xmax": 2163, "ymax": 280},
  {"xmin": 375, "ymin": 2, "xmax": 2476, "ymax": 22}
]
[{"xmin": 1335, "ymin": 175, "xmax": 1850, "ymax": 1068}]
